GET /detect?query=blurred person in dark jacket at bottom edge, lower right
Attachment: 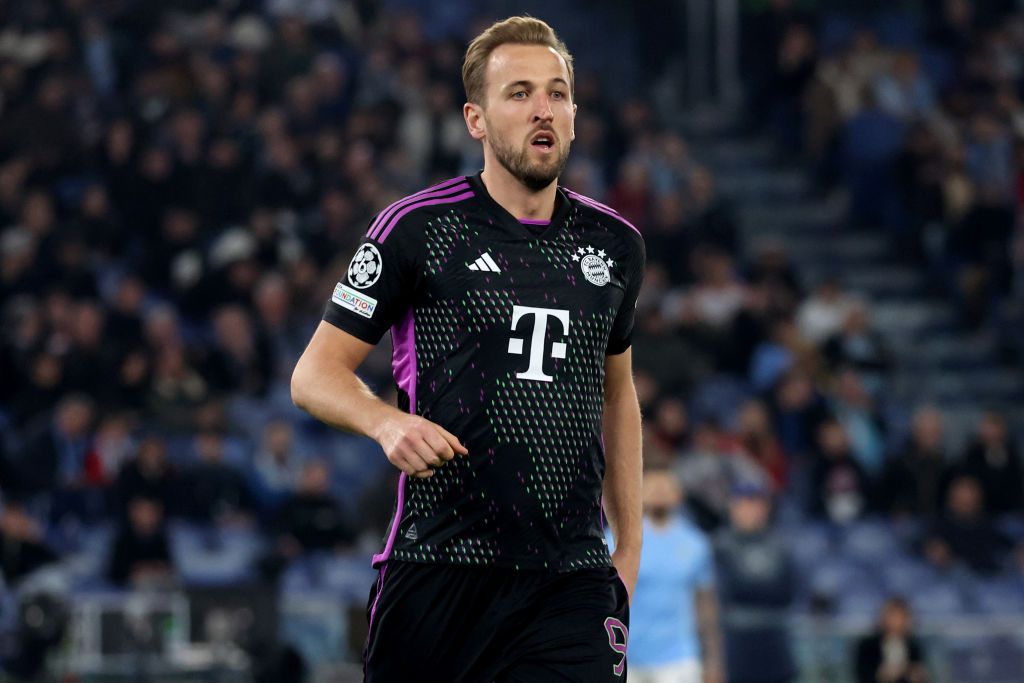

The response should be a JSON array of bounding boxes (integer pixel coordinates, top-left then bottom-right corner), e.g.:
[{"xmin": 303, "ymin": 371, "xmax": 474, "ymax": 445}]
[{"xmin": 854, "ymin": 597, "xmax": 929, "ymax": 683}]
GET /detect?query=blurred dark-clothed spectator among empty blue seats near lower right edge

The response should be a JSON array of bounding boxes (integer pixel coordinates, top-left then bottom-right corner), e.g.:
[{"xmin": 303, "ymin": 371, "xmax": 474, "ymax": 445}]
[{"xmin": 924, "ymin": 476, "xmax": 1011, "ymax": 574}]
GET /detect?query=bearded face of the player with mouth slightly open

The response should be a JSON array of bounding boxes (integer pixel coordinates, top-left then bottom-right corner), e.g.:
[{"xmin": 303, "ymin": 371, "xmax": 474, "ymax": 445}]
[{"xmin": 475, "ymin": 44, "xmax": 577, "ymax": 191}]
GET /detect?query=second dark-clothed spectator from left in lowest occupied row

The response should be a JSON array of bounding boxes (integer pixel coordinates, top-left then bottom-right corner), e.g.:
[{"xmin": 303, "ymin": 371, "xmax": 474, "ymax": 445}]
[{"xmin": 108, "ymin": 496, "xmax": 174, "ymax": 587}]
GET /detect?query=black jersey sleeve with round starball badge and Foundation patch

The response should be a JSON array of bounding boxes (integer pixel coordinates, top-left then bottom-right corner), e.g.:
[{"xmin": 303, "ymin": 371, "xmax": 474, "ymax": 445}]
[{"xmin": 324, "ymin": 216, "xmax": 423, "ymax": 344}]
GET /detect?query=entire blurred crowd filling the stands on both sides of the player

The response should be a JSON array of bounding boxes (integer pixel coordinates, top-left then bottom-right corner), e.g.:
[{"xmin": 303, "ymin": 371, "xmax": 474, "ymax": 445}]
[{"xmin": 0, "ymin": 0, "xmax": 1024, "ymax": 667}]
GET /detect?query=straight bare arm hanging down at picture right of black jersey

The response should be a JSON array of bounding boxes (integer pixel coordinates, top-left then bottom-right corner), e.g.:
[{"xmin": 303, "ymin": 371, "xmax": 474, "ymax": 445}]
[{"xmin": 603, "ymin": 349, "xmax": 643, "ymax": 596}]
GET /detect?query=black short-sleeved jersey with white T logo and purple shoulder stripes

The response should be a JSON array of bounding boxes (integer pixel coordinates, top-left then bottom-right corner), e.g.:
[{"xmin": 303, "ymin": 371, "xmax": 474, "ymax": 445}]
[{"xmin": 324, "ymin": 175, "xmax": 644, "ymax": 571}]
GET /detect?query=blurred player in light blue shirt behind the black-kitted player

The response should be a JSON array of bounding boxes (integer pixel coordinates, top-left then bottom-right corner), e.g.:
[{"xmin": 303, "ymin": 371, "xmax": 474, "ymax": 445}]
[{"xmin": 610, "ymin": 468, "xmax": 725, "ymax": 683}]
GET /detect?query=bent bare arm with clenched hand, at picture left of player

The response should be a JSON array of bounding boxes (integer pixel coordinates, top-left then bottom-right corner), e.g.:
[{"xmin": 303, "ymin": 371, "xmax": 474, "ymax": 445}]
[{"xmin": 292, "ymin": 322, "xmax": 467, "ymax": 477}]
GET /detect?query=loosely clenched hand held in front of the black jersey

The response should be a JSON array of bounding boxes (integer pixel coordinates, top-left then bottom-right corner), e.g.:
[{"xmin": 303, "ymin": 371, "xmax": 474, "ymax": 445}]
[{"xmin": 377, "ymin": 415, "xmax": 469, "ymax": 479}]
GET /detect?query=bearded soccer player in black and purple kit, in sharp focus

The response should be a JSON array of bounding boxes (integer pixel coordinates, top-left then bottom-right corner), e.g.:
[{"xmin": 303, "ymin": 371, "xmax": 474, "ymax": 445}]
[{"xmin": 292, "ymin": 17, "xmax": 644, "ymax": 683}]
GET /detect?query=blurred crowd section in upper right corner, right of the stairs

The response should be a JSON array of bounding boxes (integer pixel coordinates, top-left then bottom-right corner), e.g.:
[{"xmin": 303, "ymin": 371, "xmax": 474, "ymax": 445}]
[{"xmin": 745, "ymin": 0, "xmax": 1024, "ymax": 339}]
